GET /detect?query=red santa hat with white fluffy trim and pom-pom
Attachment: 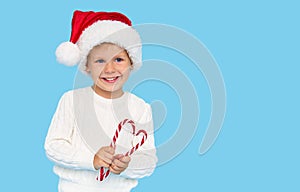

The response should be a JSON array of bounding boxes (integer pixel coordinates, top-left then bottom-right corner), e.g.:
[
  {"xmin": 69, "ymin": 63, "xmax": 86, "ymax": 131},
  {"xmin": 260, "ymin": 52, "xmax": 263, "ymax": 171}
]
[{"xmin": 55, "ymin": 10, "xmax": 142, "ymax": 71}]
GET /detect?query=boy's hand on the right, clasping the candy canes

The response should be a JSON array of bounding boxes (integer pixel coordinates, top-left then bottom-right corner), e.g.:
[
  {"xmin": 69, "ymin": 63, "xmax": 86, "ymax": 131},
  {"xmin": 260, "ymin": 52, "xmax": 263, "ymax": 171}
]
[{"xmin": 109, "ymin": 154, "xmax": 131, "ymax": 174}]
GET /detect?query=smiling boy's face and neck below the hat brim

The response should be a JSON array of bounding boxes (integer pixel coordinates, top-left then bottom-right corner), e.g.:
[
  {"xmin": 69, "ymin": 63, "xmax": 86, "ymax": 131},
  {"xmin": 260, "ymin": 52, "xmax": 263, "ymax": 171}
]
[{"xmin": 86, "ymin": 43, "xmax": 131, "ymax": 98}]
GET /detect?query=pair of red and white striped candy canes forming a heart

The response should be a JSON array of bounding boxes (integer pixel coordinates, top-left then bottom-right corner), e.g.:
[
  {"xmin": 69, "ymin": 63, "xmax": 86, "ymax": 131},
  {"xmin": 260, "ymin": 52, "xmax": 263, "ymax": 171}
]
[{"xmin": 96, "ymin": 119, "xmax": 147, "ymax": 181}]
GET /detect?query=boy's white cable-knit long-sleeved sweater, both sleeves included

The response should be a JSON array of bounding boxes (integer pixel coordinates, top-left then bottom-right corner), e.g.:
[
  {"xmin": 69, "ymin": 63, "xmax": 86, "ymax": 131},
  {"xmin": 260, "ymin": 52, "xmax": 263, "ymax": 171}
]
[{"xmin": 45, "ymin": 87, "xmax": 157, "ymax": 192}]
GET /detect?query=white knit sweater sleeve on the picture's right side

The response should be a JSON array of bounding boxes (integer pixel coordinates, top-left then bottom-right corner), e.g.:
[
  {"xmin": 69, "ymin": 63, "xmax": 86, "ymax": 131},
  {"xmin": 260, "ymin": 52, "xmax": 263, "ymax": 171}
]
[{"xmin": 121, "ymin": 103, "xmax": 157, "ymax": 179}]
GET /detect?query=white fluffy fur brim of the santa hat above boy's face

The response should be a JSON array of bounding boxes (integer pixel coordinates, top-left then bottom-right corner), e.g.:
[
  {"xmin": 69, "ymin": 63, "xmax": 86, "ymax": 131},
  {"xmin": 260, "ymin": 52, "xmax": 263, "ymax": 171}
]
[{"xmin": 77, "ymin": 20, "xmax": 142, "ymax": 72}]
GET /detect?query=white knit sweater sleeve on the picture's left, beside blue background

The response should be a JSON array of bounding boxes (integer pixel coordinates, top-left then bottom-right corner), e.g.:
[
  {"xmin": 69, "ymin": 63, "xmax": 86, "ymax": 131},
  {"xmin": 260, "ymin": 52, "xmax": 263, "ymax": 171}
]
[{"xmin": 44, "ymin": 91, "xmax": 94, "ymax": 170}]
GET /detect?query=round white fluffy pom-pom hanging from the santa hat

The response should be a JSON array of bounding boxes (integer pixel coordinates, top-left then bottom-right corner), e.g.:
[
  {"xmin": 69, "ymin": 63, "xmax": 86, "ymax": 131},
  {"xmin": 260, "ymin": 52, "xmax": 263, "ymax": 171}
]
[{"xmin": 55, "ymin": 42, "xmax": 81, "ymax": 66}]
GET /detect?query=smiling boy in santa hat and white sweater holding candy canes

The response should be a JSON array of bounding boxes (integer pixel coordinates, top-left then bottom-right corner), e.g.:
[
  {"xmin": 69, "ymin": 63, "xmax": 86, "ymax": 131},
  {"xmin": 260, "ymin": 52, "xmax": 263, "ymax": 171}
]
[{"xmin": 45, "ymin": 11, "xmax": 157, "ymax": 192}]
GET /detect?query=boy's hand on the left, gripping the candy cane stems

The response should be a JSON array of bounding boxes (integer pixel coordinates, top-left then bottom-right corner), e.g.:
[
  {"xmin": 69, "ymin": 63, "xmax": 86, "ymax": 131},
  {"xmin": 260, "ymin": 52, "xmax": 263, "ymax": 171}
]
[{"xmin": 93, "ymin": 146, "xmax": 115, "ymax": 169}]
